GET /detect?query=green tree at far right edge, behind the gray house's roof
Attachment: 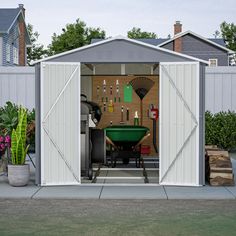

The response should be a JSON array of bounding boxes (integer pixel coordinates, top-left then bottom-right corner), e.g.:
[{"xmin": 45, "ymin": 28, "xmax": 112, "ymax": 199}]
[{"xmin": 220, "ymin": 21, "xmax": 236, "ymax": 51}]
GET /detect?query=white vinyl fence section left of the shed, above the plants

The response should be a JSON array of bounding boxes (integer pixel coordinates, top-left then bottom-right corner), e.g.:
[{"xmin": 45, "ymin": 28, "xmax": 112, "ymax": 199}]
[{"xmin": 0, "ymin": 66, "xmax": 35, "ymax": 110}]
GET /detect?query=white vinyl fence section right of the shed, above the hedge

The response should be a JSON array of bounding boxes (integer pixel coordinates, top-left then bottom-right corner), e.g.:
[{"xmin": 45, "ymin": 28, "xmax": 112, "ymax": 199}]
[{"xmin": 205, "ymin": 66, "xmax": 236, "ymax": 113}]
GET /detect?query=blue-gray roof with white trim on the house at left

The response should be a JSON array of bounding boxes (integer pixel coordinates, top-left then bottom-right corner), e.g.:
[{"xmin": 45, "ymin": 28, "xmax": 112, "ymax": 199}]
[{"xmin": 0, "ymin": 8, "xmax": 31, "ymax": 45}]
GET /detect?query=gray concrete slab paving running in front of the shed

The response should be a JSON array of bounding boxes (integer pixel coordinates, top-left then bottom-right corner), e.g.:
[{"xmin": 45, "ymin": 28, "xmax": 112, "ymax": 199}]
[{"xmin": 0, "ymin": 156, "xmax": 236, "ymax": 200}]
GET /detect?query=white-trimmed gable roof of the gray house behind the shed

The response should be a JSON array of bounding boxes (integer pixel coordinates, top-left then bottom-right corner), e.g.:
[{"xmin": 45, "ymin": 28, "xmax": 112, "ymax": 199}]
[{"xmin": 158, "ymin": 30, "xmax": 234, "ymax": 53}]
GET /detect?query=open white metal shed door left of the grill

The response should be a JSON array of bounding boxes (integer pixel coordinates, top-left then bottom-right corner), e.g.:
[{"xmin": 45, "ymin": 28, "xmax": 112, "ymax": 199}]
[{"xmin": 40, "ymin": 62, "xmax": 80, "ymax": 185}]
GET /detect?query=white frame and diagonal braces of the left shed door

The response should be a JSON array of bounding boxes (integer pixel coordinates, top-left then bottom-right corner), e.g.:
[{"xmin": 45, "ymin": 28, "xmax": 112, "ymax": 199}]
[{"xmin": 40, "ymin": 62, "xmax": 81, "ymax": 186}]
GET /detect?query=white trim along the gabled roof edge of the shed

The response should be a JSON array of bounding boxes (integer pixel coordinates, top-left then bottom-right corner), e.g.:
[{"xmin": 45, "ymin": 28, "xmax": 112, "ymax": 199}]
[{"xmin": 32, "ymin": 36, "xmax": 208, "ymax": 65}]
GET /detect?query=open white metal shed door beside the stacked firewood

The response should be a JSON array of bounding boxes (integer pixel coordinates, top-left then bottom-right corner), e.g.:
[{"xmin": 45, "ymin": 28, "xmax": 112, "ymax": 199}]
[{"xmin": 159, "ymin": 62, "xmax": 200, "ymax": 186}]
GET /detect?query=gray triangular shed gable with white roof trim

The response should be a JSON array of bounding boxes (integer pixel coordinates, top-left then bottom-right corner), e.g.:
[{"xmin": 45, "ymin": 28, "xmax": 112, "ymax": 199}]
[{"xmin": 32, "ymin": 36, "xmax": 208, "ymax": 64}]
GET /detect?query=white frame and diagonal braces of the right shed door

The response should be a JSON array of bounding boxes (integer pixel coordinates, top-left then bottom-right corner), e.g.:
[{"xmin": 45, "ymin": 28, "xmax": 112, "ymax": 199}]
[{"xmin": 159, "ymin": 62, "xmax": 200, "ymax": 186}]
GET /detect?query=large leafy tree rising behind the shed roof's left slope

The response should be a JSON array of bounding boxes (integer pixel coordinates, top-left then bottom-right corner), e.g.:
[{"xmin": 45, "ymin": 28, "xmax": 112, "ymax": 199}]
[{"xmin": 48, "ymin": 19, "xmax": 106, "ymax": 55}]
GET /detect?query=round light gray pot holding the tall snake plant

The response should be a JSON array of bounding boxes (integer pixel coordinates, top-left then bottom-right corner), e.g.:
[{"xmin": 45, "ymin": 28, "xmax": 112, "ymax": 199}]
[{"xmin": 8, "ymin": 164, "xmax": 30, "ymax": 187}]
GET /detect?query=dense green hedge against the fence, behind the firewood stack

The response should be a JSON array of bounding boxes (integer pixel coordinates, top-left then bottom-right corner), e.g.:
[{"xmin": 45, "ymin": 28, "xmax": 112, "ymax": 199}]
[{"xmin": 205, "ymin": 111, "xmax": 236, "ymax": 150}]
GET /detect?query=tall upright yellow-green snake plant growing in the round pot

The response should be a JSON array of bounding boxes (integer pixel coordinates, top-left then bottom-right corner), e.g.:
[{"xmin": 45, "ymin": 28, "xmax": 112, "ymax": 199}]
[{"xmin": 11, "ymin": 107, "xmax": 29, "ymax": 165}]
